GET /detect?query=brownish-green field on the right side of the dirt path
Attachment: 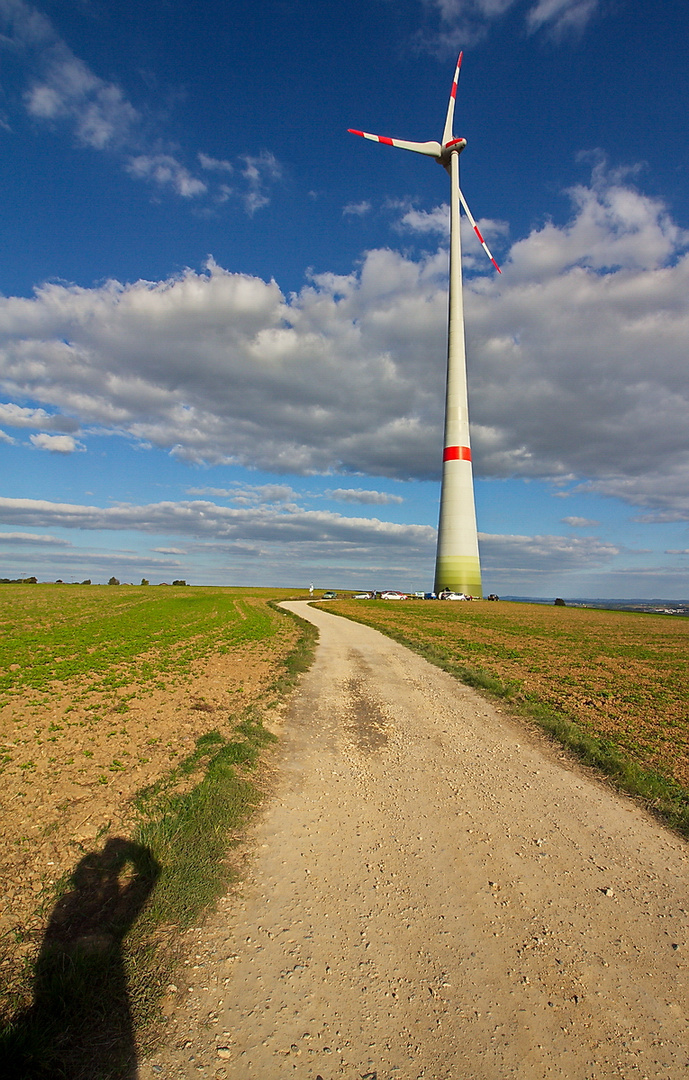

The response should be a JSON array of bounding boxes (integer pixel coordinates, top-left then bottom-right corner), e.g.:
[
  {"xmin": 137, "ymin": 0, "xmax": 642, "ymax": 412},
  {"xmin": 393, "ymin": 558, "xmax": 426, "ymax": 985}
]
[{"xmin": 327, "ymin": 600, "xmax": 689, "ymax": 832}]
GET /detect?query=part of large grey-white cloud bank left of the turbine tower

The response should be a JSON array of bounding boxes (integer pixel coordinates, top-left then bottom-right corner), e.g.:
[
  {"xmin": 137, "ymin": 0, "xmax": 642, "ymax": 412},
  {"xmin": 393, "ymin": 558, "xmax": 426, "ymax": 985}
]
[{"xmin": 0, "ymin": 252, "xmax": 446, "ymax": 475}]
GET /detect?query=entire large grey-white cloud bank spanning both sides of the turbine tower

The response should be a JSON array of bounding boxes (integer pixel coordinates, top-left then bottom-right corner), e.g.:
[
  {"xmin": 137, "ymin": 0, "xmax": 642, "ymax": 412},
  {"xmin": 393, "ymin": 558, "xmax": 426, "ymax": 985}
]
[{"xmin": 0, "ymin": 159, "xmax": 689, "ymax": 516}]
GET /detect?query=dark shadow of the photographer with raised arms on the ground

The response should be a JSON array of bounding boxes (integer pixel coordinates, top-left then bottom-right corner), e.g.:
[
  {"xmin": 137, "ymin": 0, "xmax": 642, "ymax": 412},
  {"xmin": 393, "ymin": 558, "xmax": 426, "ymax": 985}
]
[{"xmin": 2, "ymin": 837, "xmax": 160, "ymax": 1080}]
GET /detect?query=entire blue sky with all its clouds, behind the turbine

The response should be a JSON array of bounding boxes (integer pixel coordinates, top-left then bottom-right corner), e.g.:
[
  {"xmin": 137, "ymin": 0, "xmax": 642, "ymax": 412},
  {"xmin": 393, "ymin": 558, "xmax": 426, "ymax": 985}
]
[{"xmin": 0, "ymin": 0, "xmax": 689, "ymax": 598}]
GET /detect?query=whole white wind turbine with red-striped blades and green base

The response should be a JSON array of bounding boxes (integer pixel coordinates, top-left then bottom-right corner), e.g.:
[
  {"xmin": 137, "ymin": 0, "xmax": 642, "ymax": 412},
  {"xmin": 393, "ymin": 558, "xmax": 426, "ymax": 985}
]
[{"xmin": 349, "ymin": 53, "xmax": 501, "ymax": 597}]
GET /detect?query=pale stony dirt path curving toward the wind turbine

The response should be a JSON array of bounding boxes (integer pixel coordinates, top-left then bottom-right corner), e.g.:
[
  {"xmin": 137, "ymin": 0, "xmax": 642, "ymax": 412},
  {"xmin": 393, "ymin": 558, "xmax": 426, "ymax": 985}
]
[{"xmin": 139, "ymin": 603, "xmax": 689, "ymax": 1080}]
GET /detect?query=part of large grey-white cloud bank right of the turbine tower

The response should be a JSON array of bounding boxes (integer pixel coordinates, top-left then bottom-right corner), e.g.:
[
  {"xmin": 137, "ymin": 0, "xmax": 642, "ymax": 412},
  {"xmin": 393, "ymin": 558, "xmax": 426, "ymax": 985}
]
[{"xmin": 467, "ymin": 166, "xmax": 689, "ymax": 505}]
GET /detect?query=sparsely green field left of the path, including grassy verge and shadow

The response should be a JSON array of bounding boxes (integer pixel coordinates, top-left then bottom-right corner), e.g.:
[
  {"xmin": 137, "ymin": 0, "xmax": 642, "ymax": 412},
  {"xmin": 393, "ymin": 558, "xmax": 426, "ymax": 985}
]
[{"xmin": 0, "ymin": 584, "xmax": 315, "ymax": 1080}]
